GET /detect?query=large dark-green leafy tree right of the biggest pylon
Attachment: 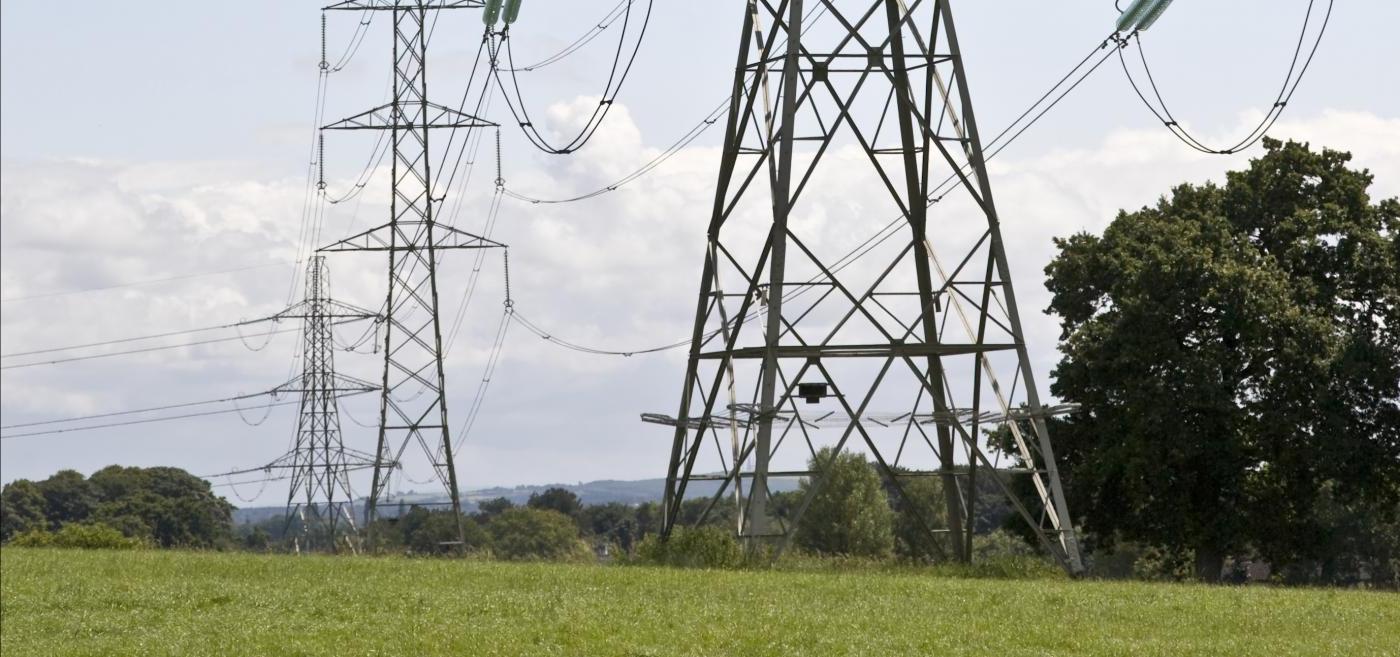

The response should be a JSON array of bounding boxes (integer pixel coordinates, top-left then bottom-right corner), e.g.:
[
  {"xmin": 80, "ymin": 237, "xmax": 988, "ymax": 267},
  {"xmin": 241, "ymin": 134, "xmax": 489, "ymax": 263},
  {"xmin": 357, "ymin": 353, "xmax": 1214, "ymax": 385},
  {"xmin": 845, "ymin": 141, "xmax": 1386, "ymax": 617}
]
[{"xmin": 1046, "ymin": 140, "xmax": 1400, "ymax": 579}]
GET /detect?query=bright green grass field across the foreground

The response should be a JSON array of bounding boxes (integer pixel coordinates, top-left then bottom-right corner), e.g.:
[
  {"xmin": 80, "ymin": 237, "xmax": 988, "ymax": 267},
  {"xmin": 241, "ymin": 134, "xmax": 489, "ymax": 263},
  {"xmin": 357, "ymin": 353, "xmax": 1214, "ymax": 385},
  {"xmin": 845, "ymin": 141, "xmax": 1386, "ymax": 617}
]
[{"xmin": 0, "ymin": 548, "xmax": 1400, "ymax": 657}]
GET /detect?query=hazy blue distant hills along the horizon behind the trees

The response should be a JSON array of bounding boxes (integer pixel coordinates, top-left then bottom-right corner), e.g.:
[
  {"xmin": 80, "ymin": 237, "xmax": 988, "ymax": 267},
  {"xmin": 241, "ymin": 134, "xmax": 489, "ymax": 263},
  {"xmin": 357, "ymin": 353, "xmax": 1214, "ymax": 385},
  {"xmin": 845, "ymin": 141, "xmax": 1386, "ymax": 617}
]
[{"xmin": 234, "ymin": 479, "xmax": 797, "ymax": 524}]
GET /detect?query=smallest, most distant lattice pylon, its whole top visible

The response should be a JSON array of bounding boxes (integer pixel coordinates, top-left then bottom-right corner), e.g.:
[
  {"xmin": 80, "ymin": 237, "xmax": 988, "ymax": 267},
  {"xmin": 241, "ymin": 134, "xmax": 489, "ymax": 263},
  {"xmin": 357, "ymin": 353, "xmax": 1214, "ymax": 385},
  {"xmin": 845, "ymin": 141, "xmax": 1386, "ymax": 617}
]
[{"xmin": 273, "ymin": 255, "xmax": 379, "ymax": 552}]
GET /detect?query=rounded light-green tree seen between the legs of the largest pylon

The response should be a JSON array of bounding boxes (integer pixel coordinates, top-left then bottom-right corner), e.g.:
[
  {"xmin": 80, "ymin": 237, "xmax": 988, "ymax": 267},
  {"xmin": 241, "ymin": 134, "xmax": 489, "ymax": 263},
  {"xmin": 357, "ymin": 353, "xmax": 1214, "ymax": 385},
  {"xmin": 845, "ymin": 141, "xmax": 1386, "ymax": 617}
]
[{"xmin": 794, "ymin": 448, "xmax": 895, "ymax": 558}]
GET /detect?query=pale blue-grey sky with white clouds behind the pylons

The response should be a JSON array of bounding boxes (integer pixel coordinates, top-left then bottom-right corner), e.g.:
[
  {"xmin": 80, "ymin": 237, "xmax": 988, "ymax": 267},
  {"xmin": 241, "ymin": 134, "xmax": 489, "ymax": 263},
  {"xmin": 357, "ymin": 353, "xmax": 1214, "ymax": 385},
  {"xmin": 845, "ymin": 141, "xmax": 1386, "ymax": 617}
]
[{"xmin": 0, "ymin": 0, "xmax": 1400, "ymax": 504}]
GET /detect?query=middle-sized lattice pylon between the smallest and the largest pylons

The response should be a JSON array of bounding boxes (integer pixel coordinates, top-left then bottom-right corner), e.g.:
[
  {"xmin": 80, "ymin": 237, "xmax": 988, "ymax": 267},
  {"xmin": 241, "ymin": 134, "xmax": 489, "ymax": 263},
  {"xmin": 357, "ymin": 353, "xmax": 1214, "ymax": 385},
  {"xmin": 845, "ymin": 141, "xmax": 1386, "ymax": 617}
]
[{"xmin": 321, "ymin": 0, "xmax": 504, "ymax": 545}]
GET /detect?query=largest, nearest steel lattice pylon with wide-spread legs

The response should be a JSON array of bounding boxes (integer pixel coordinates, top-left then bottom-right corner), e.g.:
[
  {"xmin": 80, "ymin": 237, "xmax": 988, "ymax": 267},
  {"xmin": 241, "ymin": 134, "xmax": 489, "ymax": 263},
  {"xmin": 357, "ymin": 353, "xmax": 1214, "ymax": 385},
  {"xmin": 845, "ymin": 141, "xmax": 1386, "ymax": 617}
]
[{"xmin": 644, "ymin": 0, "xmax": 1082, "ymax": 573}]
